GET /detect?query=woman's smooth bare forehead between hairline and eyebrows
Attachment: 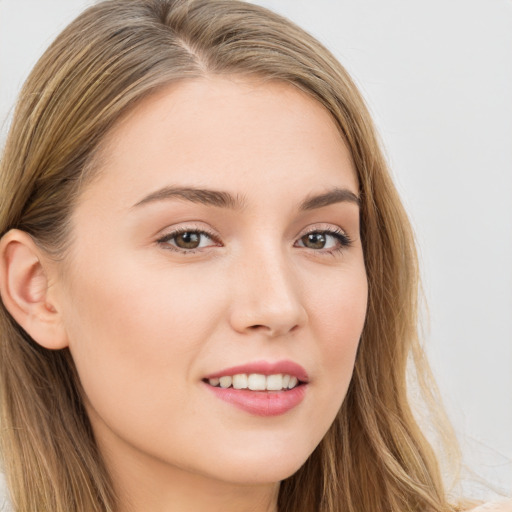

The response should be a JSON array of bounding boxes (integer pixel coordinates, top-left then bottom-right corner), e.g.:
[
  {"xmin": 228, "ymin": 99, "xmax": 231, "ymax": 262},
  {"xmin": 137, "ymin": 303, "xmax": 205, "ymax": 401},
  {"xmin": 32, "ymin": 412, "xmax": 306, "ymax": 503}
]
[{"xmin": 81, "ymin": 76, "xmax": 358, "ymax": 210}]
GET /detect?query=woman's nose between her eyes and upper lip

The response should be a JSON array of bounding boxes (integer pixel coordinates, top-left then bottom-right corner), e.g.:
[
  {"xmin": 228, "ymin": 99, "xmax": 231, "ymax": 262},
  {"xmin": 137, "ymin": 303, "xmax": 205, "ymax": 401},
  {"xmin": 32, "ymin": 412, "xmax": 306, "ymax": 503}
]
[{"xmin": 230, "ymin": 243, "xmax": 308, "ymax": 337}]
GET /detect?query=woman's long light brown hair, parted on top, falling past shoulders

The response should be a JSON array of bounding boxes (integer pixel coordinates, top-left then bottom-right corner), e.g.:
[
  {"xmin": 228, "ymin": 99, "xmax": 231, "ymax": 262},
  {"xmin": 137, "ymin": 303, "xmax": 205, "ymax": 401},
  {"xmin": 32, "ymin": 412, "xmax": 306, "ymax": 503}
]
[{"xmin": 0, "ymin": 0, "xmax": 460, "ymax": 512}]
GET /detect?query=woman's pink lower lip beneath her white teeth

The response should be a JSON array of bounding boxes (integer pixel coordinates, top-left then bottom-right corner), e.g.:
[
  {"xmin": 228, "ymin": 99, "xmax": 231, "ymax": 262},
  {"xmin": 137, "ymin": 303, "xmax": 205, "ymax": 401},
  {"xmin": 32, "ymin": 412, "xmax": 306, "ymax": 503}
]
[{"xmin": 204, "ymin": 383, "xmax": 307, "ymax": 416}]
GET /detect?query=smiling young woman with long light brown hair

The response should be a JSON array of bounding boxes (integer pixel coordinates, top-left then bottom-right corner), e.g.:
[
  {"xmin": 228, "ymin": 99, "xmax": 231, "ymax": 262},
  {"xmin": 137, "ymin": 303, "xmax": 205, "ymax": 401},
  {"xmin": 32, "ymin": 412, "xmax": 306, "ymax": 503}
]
[{"xmin": 0, "ymin": 0, "xmax": 506, "ymax": 512}]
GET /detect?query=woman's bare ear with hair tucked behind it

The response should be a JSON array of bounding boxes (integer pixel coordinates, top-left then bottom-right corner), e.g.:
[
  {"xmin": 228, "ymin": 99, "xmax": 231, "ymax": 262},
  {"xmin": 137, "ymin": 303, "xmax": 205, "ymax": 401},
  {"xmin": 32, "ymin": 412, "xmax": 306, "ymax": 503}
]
[{"xmin": 0, "ymin": 229, "xmax": 68, "ymax": 350}]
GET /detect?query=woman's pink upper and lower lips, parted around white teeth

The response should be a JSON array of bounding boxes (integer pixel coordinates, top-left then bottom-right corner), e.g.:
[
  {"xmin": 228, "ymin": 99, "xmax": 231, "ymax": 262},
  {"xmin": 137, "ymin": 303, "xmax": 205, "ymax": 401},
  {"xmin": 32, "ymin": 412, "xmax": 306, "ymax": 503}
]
[{"xmin": 203, "ymin": 361, "xmax": 309, "ymax": 416}]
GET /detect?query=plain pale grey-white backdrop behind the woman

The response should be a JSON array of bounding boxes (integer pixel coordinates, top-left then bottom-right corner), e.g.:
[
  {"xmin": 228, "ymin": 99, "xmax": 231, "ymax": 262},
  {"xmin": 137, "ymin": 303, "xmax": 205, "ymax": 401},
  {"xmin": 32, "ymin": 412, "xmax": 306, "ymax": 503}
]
[{"xmin": 0, "ymin": 0, "xmax": 512, "ymax": 506}]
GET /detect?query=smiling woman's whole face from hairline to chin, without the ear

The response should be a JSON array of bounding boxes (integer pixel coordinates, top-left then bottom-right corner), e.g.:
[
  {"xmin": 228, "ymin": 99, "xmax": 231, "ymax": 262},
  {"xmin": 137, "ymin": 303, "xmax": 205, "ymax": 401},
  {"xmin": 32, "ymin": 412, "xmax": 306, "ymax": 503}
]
[{"xmin": 55, "ymin": 78, "xmax": 367, "ymax": 483}]
